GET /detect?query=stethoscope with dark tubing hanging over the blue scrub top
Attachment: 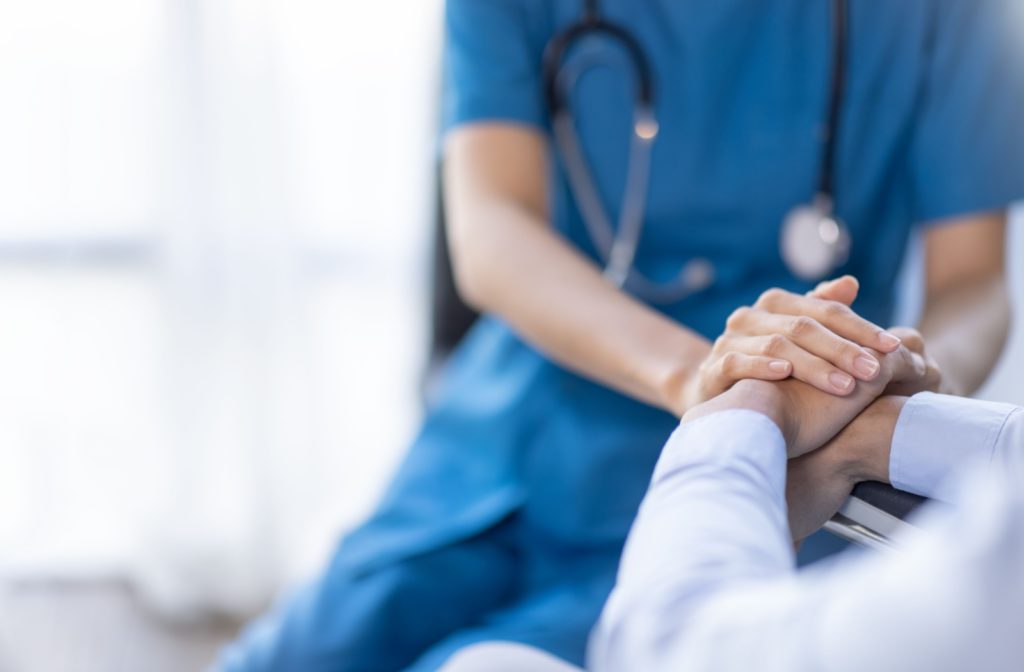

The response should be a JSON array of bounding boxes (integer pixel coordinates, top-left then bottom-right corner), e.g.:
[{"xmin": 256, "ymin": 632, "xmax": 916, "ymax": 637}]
[{"xmin": 543, "ymin": 0, "xmax": 850, "ymax": 303}]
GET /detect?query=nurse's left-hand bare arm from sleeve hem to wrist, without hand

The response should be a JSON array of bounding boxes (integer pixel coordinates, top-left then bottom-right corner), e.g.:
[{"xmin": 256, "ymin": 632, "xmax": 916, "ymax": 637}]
[{"xmin": 445, "ymin": 128, "xmax": 711, "ymax": 414}]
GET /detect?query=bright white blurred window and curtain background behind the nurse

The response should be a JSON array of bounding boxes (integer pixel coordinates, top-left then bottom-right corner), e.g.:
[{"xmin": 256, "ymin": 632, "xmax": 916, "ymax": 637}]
[{"xmin": 0, "ymin": 0, "xmax": 1024, "ymax": 672}]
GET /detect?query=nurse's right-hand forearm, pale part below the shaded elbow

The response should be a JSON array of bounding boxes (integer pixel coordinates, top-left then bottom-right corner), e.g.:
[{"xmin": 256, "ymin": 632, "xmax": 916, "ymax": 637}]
[{"xmin": 919, "ymin": 274, "xmax": 1011, "ymax": 395}]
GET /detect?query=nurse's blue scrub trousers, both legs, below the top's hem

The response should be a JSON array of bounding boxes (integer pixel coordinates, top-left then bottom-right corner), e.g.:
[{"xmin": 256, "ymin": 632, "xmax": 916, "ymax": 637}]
[{"xmin": 216, "ymin": 515, "xmax": 618, "ymax": 672}]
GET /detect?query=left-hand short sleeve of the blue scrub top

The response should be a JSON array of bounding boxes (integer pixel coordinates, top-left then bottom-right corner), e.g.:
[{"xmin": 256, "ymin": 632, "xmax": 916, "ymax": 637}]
[{"xmin": 443, "ymin": 0, "xmax": 548, "ymax": 130}]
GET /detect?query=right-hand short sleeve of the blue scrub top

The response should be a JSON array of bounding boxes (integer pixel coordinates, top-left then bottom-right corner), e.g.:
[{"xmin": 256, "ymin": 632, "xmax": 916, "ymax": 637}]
[{"xmin": 910, "ymin": 0, "xmax": 1024, "ymax": 222}]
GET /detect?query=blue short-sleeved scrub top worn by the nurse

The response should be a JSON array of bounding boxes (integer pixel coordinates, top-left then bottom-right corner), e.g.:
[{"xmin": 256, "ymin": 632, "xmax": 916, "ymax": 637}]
[{"xmin": 336, "ymin": 0, "xmax": 1024, "ymax": 568}]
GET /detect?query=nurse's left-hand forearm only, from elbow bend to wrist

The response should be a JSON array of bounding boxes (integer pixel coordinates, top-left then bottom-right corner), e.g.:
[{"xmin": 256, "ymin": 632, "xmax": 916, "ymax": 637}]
[{"xmin": 467, "ymin": 200, "xmax": 710, "ymax": 414}]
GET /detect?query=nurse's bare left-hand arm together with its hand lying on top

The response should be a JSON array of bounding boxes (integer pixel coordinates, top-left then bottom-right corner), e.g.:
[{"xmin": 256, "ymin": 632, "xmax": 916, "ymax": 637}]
[{"xmin": 444, "ymin": 124, "xmax": 898, "ymax": 415}]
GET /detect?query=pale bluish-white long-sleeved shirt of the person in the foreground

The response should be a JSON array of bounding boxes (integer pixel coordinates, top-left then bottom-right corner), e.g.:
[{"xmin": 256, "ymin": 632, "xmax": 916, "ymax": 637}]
[{"xmin": 590, "ymin": 394, "xmax": 1024, "ymax": 672}]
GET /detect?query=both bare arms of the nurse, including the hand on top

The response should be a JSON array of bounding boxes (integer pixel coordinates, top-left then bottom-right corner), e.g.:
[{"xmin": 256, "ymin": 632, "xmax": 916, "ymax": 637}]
[{"xmin": 444, "ymin": 123, "xmax": 1009, "ymax": 416}]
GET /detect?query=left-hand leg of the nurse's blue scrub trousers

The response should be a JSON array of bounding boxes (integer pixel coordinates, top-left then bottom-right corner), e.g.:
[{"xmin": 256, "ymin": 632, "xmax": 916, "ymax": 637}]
[{"xmin": 218, "ymin": 516, "xmax": 517, "ymax": 672}]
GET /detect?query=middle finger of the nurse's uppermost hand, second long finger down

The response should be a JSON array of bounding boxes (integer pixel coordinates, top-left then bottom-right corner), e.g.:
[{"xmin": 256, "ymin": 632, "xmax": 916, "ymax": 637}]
[{"xmin": 734, "ymin": 310, "xmax": 882, "ymax": 380}]
